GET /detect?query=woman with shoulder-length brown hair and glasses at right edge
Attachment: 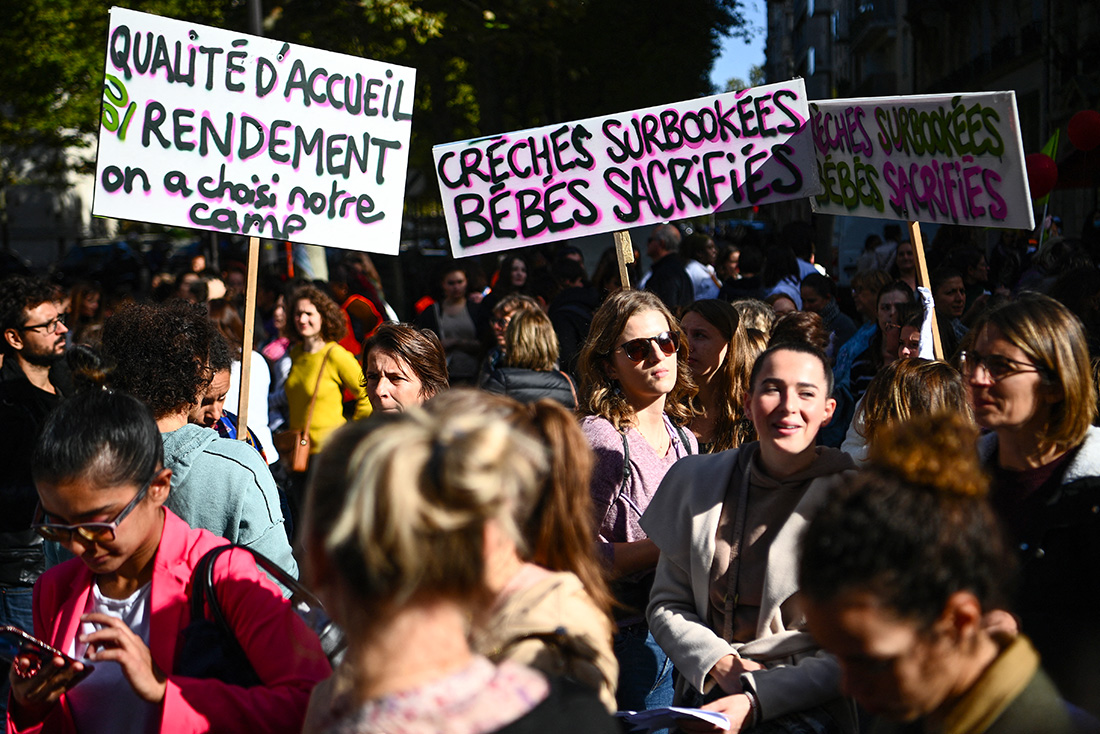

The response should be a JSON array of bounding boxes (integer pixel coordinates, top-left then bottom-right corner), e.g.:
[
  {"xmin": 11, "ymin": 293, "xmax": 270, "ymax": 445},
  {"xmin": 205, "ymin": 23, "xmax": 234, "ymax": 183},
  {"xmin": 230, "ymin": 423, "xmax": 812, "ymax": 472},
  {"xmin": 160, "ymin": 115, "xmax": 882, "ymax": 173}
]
[{"xmin": 960, "ymin": 295, "xmax": 1100, "ymax": 714}]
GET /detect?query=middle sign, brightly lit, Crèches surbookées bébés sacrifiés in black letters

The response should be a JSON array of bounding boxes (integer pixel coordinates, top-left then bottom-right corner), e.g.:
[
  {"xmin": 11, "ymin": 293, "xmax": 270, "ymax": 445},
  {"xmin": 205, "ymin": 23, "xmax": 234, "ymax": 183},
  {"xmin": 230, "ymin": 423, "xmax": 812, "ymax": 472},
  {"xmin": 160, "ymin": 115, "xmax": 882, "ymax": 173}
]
[{"xmin": 433, "ymin": 79, "xmax": 818, "ymax": 255}]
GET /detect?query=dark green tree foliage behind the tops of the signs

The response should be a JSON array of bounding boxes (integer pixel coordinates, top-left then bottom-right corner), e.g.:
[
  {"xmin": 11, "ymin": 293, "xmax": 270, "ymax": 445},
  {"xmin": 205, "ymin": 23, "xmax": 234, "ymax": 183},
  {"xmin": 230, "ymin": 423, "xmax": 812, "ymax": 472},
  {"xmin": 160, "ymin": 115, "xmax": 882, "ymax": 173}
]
[{"xmin": 0, "ymin": 0, "xmax": 747, "ymax": 201}]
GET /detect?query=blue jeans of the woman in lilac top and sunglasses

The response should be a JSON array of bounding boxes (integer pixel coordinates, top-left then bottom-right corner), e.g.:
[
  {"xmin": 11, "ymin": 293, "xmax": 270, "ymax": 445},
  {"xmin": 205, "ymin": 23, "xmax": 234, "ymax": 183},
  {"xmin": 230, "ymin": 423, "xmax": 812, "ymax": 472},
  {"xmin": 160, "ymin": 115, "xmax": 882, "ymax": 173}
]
[{"xmin": 615, "ymin": 623, "xmax": 673, "ymax": 711}]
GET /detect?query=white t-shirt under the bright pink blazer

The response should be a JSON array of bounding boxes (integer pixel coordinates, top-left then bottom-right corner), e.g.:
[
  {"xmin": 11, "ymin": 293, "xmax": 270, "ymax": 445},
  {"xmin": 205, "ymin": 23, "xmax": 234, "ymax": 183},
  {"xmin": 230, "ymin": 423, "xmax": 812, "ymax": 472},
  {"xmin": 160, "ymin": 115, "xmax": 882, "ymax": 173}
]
[{"xmin": 66, "ymin": 583, "xmax": 161, "ymax": 734}]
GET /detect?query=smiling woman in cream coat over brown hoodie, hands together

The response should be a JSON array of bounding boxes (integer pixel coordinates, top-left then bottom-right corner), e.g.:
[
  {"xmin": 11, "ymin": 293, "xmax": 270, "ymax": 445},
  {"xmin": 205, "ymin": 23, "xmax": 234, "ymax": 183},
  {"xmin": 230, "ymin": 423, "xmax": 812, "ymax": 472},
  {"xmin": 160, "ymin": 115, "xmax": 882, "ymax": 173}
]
[{"xmin": 641, "ymin": 342, "xmax": 855, "ymax": 734}]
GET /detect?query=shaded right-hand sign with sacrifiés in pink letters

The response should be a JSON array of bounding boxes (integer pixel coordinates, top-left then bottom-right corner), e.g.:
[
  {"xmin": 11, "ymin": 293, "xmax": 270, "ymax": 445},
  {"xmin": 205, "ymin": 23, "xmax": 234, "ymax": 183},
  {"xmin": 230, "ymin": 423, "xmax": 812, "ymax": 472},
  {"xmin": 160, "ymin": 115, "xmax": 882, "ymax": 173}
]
[{"xmin": 810, "ymin": 91, "xmax": 1035, "ymax": 229}]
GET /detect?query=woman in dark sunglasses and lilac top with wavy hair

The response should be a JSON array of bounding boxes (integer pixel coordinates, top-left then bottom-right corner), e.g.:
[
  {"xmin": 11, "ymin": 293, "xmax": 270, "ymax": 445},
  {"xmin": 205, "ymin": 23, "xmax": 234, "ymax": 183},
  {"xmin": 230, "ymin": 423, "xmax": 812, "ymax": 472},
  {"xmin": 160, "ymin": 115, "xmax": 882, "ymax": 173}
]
[{"xmin": 578, "ymin": 289, "xmax": 699, "ymax": 711}]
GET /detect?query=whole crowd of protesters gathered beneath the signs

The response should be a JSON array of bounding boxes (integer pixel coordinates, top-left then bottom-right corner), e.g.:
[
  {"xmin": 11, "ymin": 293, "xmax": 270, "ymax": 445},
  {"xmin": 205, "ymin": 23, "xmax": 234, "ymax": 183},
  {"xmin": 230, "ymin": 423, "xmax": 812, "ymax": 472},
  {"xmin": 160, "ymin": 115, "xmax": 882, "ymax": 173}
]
[{"xmin": 0, "ymin": 209, "xmax": 1100, "ymax": 734}]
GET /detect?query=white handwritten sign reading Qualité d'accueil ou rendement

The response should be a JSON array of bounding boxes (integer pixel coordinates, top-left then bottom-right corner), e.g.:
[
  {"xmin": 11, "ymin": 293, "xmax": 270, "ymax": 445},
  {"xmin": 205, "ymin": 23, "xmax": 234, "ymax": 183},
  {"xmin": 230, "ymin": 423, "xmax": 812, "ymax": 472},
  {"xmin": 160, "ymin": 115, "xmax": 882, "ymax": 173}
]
[{"xmin": 92, "ymin": 8, "xmax": 415, "ymax": 254}]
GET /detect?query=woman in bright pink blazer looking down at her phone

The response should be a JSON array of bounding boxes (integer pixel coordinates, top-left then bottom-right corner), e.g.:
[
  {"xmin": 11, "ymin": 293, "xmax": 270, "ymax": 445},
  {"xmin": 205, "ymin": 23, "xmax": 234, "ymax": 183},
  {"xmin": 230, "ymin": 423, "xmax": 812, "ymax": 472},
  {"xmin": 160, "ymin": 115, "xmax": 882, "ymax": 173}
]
[{"xmin": 8, "ymin": 391, "xmax": 330, "ymax": 733}]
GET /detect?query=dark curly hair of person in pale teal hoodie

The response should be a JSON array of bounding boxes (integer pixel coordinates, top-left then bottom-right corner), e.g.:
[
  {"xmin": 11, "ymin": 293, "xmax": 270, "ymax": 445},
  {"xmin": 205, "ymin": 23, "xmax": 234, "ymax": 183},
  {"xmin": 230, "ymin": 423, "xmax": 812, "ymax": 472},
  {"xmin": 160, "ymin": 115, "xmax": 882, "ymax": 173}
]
[{"xmin": 102, "ymin": 300, "xmax": 224, "ymax": 419}]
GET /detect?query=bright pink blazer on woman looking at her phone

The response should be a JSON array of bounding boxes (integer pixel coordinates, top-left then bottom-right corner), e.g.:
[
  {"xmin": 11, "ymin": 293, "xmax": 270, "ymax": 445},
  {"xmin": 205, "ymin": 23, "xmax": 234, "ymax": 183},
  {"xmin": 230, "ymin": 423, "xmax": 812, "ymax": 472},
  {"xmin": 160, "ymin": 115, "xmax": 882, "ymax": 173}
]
[{"xmin": 8, "ymin": 508, "xmax": 332, "ymax": 734}]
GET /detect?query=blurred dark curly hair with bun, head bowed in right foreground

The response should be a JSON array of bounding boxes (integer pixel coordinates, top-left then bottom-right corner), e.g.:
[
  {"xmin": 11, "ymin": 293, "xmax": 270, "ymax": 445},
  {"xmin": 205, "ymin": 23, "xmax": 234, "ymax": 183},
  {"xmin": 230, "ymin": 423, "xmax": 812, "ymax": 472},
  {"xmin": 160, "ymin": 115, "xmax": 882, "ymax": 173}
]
[{"xmin": 800, "ymin": 413, "xmax": 1014, "ymax": 628}]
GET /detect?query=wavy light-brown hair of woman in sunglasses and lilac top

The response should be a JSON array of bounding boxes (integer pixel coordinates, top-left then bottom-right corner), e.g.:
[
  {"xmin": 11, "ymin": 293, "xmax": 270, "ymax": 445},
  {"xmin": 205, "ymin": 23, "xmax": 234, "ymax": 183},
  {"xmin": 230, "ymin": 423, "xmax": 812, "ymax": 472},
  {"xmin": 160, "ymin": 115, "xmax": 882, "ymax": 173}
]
[{"xmin": 576, "ymin": 289, "xmax": 696, "ymax": 430}]
